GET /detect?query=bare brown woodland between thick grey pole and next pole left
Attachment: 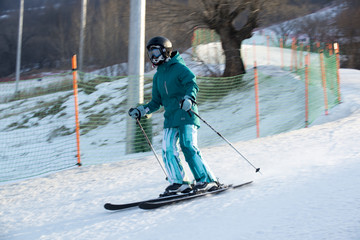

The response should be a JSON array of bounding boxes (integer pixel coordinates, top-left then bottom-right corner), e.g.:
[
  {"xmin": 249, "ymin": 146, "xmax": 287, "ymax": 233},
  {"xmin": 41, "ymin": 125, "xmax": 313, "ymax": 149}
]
[{"xmin": 85, "ymin": 0, "xmax": 129, "ymax": 66}]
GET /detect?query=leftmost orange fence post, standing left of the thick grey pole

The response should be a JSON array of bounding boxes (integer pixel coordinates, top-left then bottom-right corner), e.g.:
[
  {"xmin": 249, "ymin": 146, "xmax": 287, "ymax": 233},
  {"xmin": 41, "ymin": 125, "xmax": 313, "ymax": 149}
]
[{"xmin": 72, "ymin": 55, "xmax": 81, "ymax": 166}]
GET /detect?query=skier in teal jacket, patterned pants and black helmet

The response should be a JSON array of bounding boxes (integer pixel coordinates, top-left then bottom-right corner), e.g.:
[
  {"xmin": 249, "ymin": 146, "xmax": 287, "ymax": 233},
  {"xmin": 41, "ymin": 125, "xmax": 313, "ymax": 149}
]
[{"xmin": 128, "ymin": 36, "xmax": 220, "ymax": 196}]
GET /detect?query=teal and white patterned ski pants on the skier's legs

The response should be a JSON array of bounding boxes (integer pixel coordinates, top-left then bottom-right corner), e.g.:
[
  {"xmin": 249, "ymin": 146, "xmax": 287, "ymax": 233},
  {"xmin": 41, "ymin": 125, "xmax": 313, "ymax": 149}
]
[{"xmin": 162, "ymin": 125, "xmax": 216, "ymax": 184}]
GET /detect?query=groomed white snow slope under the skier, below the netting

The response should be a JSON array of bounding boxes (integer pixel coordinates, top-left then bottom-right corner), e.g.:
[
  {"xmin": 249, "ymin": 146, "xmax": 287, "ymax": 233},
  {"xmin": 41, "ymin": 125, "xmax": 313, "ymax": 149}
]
[{"xmin": 0, "ymin": 69, "xmax": 360, "ymax": 240}]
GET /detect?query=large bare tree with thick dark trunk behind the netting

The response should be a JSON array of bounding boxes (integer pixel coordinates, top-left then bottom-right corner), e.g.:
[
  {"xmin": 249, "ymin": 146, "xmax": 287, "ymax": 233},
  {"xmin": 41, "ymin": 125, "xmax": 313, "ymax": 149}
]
[{"xmin": 149, "ymin": 0, "xmax": 262, "ymax": 76}]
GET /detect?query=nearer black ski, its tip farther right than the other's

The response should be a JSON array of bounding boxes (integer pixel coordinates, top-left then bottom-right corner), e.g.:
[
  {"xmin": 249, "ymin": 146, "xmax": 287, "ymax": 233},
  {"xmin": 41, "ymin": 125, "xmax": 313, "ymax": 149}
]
[{"xmin": 138, "ymin": 181, "xmax": 252, "ymax": 210}]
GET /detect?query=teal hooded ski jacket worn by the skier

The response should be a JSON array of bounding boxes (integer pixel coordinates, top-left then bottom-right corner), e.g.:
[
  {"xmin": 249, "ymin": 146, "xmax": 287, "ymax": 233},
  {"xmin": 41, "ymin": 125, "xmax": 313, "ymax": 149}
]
[{"xmin": 144, "ymin": 51, "xmax": 200, "ymax": 128}]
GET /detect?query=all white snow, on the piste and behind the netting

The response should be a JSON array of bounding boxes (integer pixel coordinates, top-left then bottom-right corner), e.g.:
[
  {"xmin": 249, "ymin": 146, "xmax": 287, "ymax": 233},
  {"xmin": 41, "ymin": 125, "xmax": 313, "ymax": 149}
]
[{"xmin": 0, "ymin": 5, "xmax": 360, "ymax": 236}]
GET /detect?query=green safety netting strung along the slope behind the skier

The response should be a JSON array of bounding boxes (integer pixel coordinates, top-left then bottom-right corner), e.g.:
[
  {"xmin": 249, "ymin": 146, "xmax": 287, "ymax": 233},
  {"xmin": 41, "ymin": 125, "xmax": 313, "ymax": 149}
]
[{"xmin": 0, "ymin": 29, "xmax": 340, "ymax": 182}]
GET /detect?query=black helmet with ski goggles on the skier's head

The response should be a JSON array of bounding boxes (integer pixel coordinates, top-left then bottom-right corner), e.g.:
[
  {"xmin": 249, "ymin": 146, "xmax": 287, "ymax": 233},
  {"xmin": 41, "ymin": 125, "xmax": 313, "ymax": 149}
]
[{"xmin": 146, "ymin": 36, "xmax": 172, "ymax": 65}]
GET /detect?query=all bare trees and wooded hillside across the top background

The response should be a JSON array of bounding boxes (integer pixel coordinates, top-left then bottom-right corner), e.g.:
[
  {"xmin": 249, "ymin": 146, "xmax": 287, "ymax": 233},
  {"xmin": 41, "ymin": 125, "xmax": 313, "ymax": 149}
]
[{"xmin": 0, "ymin": 0, "xmax": 360, "ymax": 77}]
